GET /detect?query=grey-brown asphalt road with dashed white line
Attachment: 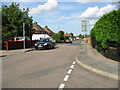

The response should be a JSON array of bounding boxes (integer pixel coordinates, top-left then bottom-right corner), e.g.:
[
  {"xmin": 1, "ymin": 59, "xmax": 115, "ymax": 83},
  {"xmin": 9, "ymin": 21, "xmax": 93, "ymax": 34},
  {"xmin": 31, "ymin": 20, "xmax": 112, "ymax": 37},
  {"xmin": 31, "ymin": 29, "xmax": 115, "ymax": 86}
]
[{"xmin": 2, "ymin": 42, "xmax": 118, "ymax": 88}]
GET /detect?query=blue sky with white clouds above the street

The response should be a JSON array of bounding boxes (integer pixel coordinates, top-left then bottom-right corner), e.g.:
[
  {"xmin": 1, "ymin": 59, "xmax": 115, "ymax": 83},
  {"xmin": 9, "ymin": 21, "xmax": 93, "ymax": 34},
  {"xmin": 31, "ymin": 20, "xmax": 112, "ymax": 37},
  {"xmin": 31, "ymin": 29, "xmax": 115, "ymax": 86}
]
[{"xmin": 2, "ymin": 0, "xmax": 118, "ymax": 35}]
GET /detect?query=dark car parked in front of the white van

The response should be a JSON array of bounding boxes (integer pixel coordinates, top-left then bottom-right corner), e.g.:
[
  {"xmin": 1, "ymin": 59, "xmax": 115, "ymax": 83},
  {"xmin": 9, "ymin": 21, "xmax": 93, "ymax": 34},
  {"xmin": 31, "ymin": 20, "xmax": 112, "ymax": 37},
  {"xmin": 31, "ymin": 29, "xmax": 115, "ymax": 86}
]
[{"xmin": 35, "ymin": 38, "xmax": 55, "ymax": 50}]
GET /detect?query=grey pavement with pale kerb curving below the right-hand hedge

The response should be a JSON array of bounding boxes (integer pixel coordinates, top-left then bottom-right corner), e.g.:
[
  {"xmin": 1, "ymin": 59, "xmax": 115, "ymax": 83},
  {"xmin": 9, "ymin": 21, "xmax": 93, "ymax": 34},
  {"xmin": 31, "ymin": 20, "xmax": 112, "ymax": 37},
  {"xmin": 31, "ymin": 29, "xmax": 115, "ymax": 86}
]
[{"xmin": 76, "ymin": 44, "xmax": 120, "ymax": 80}]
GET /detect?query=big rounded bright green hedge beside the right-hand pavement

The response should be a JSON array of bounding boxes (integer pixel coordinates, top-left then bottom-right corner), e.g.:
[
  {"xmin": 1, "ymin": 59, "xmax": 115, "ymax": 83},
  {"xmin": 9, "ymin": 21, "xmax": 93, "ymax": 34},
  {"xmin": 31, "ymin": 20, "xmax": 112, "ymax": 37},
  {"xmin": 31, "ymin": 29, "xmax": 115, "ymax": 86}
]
[{"xmin": 90, "ymin": 9, "xmax": 120, "ymax": 51}]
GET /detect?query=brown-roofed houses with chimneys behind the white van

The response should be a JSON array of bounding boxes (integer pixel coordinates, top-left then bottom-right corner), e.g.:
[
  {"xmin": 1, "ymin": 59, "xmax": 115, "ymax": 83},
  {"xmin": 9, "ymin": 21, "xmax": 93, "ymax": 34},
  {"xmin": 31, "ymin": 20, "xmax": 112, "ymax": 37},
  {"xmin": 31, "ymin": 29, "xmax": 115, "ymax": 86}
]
[{"xmin": 32, "ymin": 22, "xmax": 54, "ymax": 36}]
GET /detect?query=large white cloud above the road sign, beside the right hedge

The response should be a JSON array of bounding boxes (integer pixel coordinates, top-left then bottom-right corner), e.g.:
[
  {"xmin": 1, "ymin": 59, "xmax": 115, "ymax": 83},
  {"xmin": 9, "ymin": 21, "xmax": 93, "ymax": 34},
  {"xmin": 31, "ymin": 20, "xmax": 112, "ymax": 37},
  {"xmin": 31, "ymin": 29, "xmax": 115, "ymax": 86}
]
[{"xmin": 79, "ymin": 4, "xmax": 117, "ymax": 18}]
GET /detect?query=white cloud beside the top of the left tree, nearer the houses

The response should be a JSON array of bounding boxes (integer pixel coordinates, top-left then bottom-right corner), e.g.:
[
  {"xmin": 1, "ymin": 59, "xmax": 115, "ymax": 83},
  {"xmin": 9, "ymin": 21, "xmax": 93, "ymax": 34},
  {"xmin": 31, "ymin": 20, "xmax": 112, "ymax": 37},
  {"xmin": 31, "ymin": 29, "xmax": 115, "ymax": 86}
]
[{"xmin": 29, "ymin": 0, "xmax": 58, "ymax": 15}]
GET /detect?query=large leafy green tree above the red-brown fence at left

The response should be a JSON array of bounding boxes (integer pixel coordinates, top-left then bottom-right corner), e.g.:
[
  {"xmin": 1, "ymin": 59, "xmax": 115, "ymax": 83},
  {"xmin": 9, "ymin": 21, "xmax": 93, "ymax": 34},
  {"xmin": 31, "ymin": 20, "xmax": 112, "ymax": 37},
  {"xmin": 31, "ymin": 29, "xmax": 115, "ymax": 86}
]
[{"xmin": 2, "ymin": 3, "xmax": 33, "ymax": 41}]
